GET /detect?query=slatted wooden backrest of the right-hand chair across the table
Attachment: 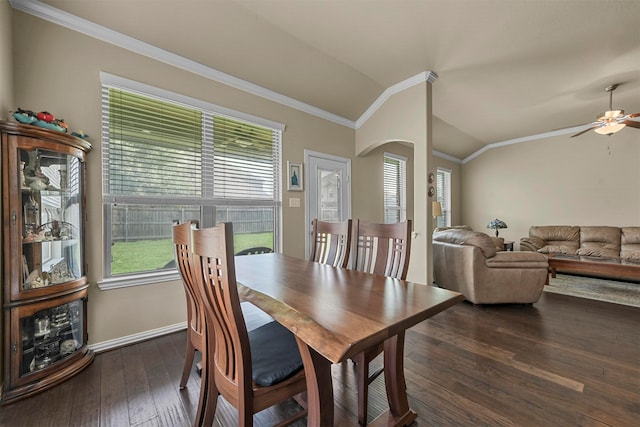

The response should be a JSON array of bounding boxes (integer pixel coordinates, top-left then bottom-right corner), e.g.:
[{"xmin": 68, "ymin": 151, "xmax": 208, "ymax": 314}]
[{"xmin": 354, "ymin": 220, "xmax": 411, "ymax": 280}]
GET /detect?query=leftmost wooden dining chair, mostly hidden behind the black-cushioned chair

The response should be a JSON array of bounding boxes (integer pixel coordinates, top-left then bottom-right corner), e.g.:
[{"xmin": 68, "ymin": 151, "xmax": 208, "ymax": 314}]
[{"xmin": 173, "ymin": 220, "xmax": 212, "ymax": 426}]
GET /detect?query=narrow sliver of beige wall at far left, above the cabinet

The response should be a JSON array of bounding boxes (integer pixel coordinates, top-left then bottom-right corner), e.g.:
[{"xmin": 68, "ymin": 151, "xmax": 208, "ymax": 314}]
[{"xmin": 0, "ymin": 0, "xmax": 16, "ymax": 120}]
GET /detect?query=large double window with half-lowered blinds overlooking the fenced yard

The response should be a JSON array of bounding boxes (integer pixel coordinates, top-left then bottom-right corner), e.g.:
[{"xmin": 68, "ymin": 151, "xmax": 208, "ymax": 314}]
[{"xmin": 101, "ymin": 74, "xmax": 282, "ymax": 288}]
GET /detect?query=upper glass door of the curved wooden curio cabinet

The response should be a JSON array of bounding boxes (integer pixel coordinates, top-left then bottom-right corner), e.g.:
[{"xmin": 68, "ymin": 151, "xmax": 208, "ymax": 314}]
[{"xmin": 18, "ymin": 149, "xmax": 83, "ymax": 290}]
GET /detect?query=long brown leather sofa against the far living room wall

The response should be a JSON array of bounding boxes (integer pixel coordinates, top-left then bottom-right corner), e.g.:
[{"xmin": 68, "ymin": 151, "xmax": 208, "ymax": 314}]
[{"xmin": 520, "ymin": 225, "xmax": 640, "ymax": 281}]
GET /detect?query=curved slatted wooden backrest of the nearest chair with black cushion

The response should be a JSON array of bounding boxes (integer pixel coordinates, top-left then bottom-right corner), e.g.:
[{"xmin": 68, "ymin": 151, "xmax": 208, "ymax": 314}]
[{"xmin": 192, "ymin": 223, "xmax": 252, "ymax": 399}]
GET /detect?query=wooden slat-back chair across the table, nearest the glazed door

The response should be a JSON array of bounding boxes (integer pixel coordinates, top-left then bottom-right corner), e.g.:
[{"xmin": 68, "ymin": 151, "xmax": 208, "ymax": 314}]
[{"xmin": 310, "ymin": 219, "xmax": 353, "ymax": 268}]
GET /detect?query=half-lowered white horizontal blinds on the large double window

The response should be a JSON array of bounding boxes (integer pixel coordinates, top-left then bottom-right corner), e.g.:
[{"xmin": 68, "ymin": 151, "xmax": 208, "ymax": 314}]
[{"xmin": 102, "ymin": 86, "xmax": 281, "ymax": 205}]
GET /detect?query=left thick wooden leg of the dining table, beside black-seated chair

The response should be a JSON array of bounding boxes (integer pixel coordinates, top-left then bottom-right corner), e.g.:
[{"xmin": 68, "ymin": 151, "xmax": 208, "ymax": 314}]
[{"xmin": 296, "ymin": 337, "xmax": 334, "ymax": 427}]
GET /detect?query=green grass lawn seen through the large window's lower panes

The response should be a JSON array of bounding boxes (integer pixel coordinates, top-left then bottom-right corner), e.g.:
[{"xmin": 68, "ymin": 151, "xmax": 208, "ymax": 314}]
[{"xmin": 111, "ymin": 233, "xmax": 273, "ymax": 275}]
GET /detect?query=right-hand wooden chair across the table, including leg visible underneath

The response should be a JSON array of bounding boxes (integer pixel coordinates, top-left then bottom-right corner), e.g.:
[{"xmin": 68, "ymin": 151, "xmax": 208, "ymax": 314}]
[{"xmin": 352, "ymin": 219, "xmax": 411, "ymax": 425}]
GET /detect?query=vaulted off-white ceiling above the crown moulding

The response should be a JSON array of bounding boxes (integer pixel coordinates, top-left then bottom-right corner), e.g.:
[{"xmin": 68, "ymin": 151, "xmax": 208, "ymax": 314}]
[{"xmin": 27, "ymin": 0, "xmax": 640, "ymax": 159}]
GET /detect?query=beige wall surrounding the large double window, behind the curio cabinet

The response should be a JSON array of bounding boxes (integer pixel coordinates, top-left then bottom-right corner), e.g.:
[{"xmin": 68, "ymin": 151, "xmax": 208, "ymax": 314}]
[{"xmin": 13, "ymin": 11, "xmax": 352, "ymax": 344}]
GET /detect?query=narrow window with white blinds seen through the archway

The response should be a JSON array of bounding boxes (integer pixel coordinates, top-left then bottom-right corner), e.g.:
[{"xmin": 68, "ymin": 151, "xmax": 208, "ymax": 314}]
[{"xmin": 384, "ymin": 153, "xmax": 407, "ymax": 224}]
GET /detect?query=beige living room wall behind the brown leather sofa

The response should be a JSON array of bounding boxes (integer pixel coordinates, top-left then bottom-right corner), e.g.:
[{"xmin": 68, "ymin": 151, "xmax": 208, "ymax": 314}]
[{"xmin": 461, "ymin": 129, "xmax": 640, "ymax": 247}]
